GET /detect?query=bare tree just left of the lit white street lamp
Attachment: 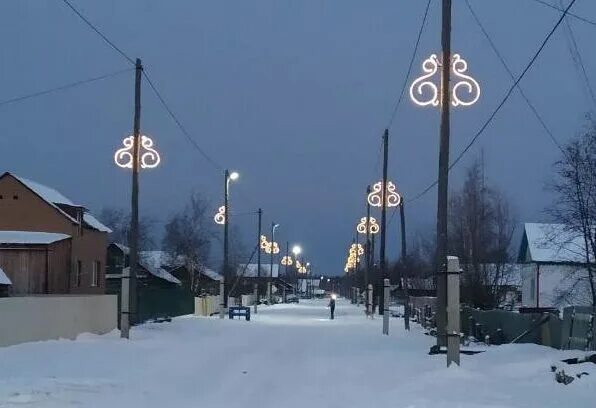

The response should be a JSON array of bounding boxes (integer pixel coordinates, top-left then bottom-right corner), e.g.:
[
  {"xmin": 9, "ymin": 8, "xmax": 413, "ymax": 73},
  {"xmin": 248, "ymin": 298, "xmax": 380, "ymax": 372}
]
[{"xmin": 162, "ymin": 193, "xmax": 213, "ymax": 291}]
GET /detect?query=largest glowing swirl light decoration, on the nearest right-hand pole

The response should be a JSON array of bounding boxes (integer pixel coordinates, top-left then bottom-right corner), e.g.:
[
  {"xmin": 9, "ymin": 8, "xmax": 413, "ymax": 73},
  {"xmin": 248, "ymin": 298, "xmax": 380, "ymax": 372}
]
[{"xmin": 410, "ymin": 54, "xmax": 480, "ymax": 106}]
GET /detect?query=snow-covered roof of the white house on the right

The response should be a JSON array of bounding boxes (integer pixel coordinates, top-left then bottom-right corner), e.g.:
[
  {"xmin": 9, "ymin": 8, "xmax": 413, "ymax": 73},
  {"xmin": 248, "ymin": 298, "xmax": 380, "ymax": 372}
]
[{"xmin": 520, "ymin": 223, "xmax": 586, "ymax": 264}]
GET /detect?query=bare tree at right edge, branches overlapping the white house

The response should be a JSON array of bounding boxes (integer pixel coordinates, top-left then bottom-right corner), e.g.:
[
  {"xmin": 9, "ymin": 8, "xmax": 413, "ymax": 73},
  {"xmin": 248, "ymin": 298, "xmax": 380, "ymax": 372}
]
[{"xmin": 549, "ymin": 121, "xmax": 596, "ymax": 306}]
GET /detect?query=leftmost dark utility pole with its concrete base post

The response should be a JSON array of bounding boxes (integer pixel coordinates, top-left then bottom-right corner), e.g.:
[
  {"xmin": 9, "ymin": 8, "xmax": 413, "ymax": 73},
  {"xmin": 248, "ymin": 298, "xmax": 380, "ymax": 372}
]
[{"xmin": 120, "ymin": 58, "xmax": 143, "ymax": 339}]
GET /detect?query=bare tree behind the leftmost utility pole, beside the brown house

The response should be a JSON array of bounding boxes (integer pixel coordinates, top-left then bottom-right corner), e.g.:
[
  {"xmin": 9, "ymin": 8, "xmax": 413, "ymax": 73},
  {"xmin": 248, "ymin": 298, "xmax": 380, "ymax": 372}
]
[{"xmin": 99, "ymin": 207, "xmax": 155, "ymax": 251}]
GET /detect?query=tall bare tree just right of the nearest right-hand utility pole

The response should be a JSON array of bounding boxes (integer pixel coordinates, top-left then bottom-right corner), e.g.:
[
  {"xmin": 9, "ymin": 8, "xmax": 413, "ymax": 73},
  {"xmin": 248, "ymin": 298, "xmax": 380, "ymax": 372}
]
[{"xmin": 449, "ymin": 161, "xmax": 515, "ymax": 308}]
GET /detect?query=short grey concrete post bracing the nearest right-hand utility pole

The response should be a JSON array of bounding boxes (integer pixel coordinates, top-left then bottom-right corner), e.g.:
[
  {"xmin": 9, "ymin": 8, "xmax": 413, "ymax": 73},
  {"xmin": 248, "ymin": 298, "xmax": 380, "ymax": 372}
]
[{"xmin": 447, "ymin": 256, "xmax": 461, "ymax": 367}]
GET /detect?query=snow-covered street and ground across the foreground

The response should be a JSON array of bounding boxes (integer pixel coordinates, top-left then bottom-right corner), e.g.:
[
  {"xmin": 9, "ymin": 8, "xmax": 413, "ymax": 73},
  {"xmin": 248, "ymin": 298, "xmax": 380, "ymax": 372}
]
[{"xmin": 0, "ymin": 300, "xmax": 596, "ymax": 408}]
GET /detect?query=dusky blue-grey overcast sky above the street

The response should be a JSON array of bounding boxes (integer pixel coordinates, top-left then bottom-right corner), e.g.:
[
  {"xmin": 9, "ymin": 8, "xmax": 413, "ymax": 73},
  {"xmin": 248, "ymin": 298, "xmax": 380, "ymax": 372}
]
[{"xmin": 0, "ymin": 0, "xmax": 596, "ymax": 274}]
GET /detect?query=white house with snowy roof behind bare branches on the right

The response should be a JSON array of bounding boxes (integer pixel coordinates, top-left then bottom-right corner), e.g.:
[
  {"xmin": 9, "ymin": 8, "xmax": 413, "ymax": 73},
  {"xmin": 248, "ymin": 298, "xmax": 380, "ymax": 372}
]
[{"xmin": 518, "ymin": 223, "xmax": 593, "ymax": 308}]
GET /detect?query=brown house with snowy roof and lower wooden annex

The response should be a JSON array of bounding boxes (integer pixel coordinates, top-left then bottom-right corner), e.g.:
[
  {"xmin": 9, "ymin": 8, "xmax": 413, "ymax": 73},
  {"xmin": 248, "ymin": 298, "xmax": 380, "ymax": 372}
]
[{"xmin": 0, "ymin": 173, "xmax": 110, "ymax": 295}]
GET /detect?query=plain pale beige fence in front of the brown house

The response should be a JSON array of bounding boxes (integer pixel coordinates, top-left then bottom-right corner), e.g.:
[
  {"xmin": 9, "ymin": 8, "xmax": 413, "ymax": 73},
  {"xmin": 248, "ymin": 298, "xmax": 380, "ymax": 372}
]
[{"xmin": 0, "ymin": 295, "xmax": 118, "ymax": 346}]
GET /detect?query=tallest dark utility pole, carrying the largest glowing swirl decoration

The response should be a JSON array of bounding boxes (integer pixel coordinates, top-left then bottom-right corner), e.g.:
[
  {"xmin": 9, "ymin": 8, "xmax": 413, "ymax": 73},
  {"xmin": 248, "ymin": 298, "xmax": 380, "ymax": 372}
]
[{"xmin": 436, "ymin": 0, "xmax": 451, "ymax": 347}]
